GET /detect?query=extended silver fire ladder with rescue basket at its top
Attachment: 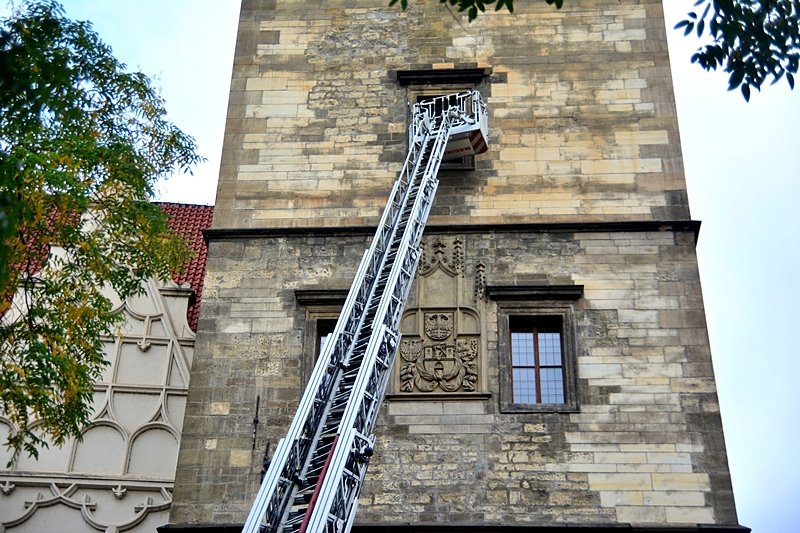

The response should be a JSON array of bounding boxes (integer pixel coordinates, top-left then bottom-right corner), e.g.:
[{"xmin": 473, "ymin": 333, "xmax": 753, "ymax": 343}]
[{"xmin": 243, "ymin": 91, "xmax": 488, "ymax": 533}]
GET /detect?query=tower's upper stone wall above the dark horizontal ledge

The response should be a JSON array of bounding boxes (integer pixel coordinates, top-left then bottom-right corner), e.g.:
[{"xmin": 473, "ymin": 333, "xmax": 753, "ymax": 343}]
[{"xmin": 215, "ymin": 0, "xmax": 688, "ymax": 228}]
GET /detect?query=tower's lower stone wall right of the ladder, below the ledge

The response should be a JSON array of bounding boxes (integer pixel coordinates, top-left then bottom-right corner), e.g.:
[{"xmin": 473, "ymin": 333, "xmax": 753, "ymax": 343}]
[{"xmin": 359, "ymin": 228, "xmax": 736, "ymax": 525}]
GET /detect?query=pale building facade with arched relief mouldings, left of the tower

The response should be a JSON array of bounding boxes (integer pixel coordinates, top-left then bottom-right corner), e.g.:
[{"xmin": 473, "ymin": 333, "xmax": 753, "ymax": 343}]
[{"xmin": 0, "ymin": 280, "xmax": 194, "ymax": 533}]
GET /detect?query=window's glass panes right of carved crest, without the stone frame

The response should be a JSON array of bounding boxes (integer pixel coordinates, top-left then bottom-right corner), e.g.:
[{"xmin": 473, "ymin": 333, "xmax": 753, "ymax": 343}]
[{"xmin": 509, "ymin": 316, "xmax": 564, "ymax": 404}]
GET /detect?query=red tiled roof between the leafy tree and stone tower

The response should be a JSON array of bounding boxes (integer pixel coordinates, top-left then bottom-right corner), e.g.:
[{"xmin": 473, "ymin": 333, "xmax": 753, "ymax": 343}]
[{"xmin": 157, "ymin": 202, "xmax": 214, "ymax": 331}]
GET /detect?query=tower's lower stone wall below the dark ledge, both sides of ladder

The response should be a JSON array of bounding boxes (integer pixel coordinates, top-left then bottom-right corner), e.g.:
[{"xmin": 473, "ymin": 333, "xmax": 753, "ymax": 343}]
[{"xmin": 172, "ymin": 227, "xmax": 736, "ymax": 525}]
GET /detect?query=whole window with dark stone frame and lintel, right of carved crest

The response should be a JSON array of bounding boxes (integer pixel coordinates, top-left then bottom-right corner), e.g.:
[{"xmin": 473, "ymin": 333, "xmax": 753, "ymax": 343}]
[{"xmin": 486, "ymin": 285, "xmax": 583, "ymax": 413}]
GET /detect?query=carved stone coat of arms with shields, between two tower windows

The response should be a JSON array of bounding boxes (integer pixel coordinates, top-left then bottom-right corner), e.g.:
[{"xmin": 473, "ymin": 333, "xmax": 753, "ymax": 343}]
[{"xmin": 400, "ymin": 312, "xmax": 478, "ymax": 392}]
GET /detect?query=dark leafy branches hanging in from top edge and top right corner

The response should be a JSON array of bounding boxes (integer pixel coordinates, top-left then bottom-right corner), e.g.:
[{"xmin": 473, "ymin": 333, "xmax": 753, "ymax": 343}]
[{"xmin": 389, "ymin": 0, "xmax": 800, "ymax": 100}]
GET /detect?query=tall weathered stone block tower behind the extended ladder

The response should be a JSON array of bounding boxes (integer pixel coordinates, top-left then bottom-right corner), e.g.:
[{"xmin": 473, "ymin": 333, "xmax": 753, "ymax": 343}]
[{"xmin": 170, "ymin": 0, "xmax": 747, "ymax": 532}]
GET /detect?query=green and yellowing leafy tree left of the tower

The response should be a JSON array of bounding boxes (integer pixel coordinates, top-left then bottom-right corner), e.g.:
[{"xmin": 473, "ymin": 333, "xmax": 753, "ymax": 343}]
[{"xmin": 0, "ymin": 0, "xmax": 199, "ymax": 462}]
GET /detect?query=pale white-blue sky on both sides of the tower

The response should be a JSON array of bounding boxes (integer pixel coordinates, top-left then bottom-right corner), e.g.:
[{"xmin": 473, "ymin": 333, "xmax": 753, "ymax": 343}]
[{"xmin": 14, "ymin": 0, "xmax": 800, "ymax": 533}]
